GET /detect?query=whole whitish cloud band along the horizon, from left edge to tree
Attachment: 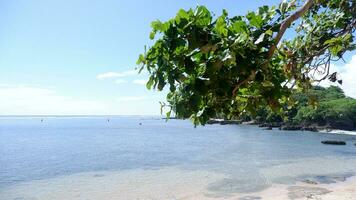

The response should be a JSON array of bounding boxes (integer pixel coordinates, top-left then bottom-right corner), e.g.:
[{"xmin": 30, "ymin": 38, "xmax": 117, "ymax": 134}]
[{"xmin": 0, "ymin": 84, "xmax": 165, "ymax": 115}]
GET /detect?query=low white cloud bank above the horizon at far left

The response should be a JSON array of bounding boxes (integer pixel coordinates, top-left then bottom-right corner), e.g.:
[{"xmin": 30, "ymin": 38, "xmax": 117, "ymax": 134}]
[{"xmin": 0, "ymin": 86, "xmax": 105, "ymax": 115}]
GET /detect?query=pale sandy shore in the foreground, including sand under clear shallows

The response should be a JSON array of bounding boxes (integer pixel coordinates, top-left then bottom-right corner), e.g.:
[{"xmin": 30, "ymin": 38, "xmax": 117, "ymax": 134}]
[{"xmin": 0, "ymin": 168, "xmax": 356, "ymax": 200}]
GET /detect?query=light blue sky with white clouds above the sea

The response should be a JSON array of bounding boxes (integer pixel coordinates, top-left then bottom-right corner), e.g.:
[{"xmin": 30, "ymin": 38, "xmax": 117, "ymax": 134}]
[{"xmin": 0, "ymin": 0, "xmax": 356, "ymax": 115}]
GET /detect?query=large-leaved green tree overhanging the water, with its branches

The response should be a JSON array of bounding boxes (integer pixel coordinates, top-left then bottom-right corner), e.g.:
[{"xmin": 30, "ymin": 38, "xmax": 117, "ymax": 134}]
[{"xmin": 138, "ymin": 0, "xmax": 356, "ymax": 124}]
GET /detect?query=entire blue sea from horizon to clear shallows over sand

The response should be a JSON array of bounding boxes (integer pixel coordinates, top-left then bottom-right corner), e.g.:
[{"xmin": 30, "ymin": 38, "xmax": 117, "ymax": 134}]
[{"xmin": 0, "ymin": 116, "xmax": 356, "ymax": 200}]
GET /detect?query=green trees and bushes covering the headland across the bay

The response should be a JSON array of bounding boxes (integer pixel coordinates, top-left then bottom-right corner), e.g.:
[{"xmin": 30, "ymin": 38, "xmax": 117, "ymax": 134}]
[{"xmin": 250, "ymin": 86, "xmax": 356, "ymax": 129}]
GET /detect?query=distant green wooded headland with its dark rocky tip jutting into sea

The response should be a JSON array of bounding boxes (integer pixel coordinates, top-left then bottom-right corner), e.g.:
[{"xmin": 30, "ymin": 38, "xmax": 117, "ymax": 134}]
[{"xmin": 208, "ymin": 86, "xmax": 356, "ymax": 131}]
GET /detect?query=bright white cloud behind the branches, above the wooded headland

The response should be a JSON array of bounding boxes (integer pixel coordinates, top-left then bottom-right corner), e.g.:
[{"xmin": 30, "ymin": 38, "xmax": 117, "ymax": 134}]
[{"xmin": 320, "ymin": 55, "xmax": 356, "ymax": 98}]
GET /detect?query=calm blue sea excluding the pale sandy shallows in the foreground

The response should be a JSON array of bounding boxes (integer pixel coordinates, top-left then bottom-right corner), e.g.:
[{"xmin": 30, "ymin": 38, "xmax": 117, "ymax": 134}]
[{"xmin": 0, "ymin": 117, "xmax": 356, "ymax": 195}]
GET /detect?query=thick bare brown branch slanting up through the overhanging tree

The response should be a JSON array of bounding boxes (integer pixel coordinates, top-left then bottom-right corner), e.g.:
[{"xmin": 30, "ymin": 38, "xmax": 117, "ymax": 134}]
[{"xmin": 268, "ymin": 0, "xmax": 314, "ymax": 59}]
